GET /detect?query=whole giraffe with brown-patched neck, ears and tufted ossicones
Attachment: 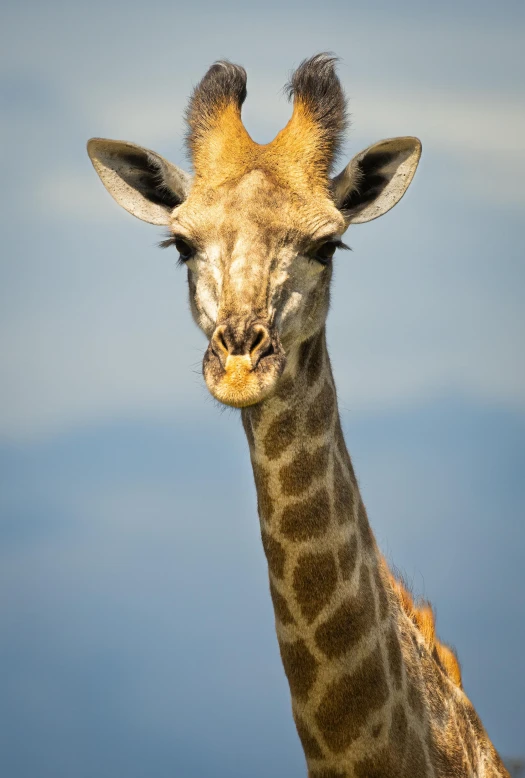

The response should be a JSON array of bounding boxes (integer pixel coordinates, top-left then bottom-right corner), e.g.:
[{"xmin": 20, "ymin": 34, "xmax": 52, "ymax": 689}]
[{"xmin": 88, "ymin": 54, "xmax": 508, "ymax": 778}]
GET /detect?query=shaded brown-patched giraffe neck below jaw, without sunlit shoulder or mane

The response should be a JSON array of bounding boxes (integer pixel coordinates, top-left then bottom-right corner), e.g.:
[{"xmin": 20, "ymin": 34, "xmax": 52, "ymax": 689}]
[{"xmin": 243, "ymin": 331, "xmax": 401, "ymax": 776}]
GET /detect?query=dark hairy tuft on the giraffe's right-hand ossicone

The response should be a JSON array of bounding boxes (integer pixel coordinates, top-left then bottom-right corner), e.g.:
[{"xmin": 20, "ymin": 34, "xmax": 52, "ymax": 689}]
[{"xmin": 285, "ymin": 52, "xmax": 349, "ymax": 167}]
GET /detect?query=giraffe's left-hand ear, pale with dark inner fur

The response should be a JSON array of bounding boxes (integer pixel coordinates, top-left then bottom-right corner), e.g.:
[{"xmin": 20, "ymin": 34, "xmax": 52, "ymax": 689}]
[{"xmin": 87, "ymin": 138, "xmax": 191, "ymax": 225}]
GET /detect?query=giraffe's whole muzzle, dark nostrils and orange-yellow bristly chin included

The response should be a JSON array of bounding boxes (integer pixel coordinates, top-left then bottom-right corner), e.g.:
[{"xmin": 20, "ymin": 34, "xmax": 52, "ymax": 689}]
[{"xmin": 203, "ymin": 320, "xmax": 285, "ymax": 408}]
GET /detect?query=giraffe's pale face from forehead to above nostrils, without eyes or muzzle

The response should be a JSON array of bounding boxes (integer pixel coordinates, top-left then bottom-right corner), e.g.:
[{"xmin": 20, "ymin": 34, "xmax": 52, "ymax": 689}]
[{"xmin": 172, "ymin": 170, "xmax": 344, "ymax": 351}]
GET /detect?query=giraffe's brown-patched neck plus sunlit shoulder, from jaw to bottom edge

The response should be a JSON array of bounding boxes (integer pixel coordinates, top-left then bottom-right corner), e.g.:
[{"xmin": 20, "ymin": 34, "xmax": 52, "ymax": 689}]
[{"xmin": 242, "ymin": 330, "xmax": 508, "ymax": 778}]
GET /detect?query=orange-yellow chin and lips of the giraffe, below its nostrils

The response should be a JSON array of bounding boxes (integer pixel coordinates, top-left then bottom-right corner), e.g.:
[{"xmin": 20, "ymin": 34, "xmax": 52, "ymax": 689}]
[{"xmin": 203, "ymin": 351, "xmax": 284, "ymax": 408}]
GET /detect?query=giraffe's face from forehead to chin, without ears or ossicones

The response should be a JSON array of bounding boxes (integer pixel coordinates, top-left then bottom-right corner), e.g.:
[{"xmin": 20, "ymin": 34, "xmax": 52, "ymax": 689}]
[{"xmin": 170, "ymin": 169, "xmax": 345, "ymax": 407}]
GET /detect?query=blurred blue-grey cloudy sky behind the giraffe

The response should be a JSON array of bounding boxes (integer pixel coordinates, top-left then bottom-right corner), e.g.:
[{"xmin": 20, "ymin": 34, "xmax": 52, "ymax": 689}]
[{"xmin": 0, "ymin": 0, "xmax": 525, "ymax": 778}]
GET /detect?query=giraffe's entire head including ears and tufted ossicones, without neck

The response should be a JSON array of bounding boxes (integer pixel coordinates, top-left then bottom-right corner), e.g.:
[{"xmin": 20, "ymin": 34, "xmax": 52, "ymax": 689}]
[{"xmin": 88, "ymin": 54, "xmax": 421, "ymax": 407}]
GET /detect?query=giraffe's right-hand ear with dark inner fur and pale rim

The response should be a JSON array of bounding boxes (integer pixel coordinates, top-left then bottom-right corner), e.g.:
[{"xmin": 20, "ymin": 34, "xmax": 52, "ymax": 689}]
[{"xmin": 331, "ymin": 137, "xmax": 421, "ymax": 225}]
